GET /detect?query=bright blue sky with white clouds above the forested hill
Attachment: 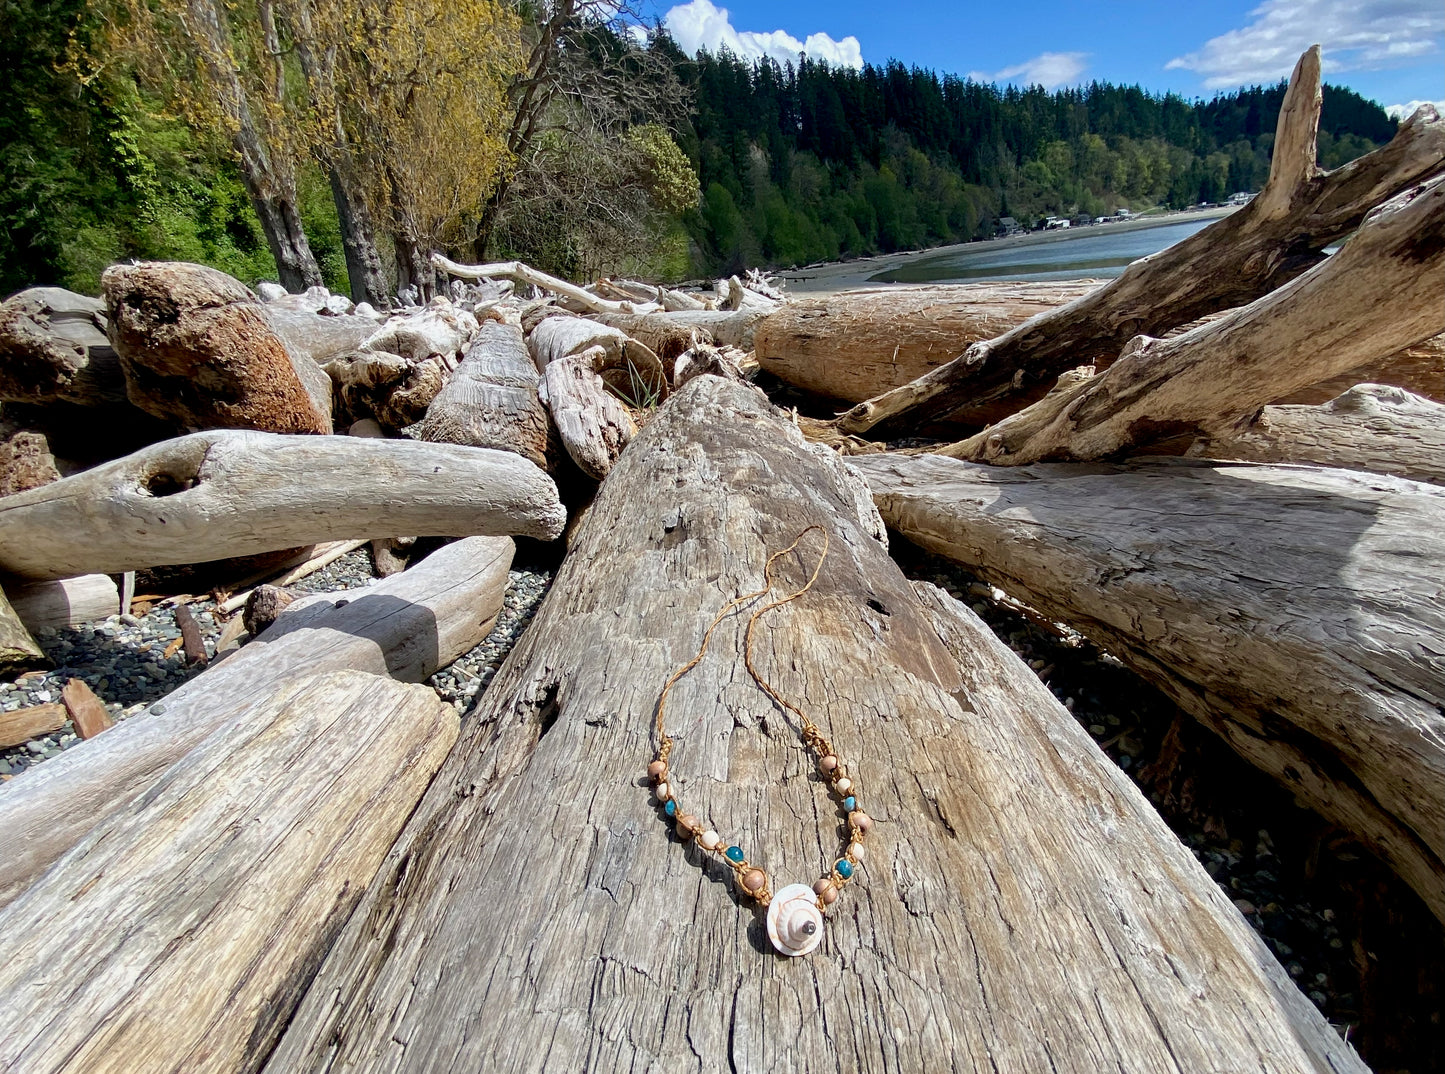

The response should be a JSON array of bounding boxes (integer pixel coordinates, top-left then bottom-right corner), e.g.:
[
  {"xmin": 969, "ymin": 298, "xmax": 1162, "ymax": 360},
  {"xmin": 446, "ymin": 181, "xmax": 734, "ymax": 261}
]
[{"xmin": 653, "ymin": 0, "xmax": 1445, "ymax": 114}]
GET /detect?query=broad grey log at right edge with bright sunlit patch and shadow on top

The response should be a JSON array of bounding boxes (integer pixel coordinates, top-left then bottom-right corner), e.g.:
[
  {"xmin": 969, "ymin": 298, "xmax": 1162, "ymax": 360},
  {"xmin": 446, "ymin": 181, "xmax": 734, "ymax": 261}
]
[{"xmin": 853, "ymin": 455, "xmax": 1445, "ymax": 919}]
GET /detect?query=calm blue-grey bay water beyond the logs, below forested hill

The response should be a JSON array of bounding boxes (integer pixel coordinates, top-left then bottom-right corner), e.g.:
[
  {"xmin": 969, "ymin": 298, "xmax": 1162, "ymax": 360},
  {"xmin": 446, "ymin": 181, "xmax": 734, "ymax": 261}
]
[{"xmin": 868, "ymin": 220, "xmax": 1214, "ymax": 283}]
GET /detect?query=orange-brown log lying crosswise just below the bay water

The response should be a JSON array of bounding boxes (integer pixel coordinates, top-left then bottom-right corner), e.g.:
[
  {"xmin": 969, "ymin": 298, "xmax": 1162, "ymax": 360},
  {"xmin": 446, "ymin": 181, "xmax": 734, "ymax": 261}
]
[{"xmin": 754, "ymin": 280, "xmax": 1098, "ymax": 421}]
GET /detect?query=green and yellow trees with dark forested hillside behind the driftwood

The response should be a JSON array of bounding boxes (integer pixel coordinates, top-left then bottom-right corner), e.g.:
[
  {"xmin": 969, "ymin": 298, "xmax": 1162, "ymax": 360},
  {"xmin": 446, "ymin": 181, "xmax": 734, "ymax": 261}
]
[{"xmin": 0, "ymin": 0, "xmax": 1396, "ymax": 304}]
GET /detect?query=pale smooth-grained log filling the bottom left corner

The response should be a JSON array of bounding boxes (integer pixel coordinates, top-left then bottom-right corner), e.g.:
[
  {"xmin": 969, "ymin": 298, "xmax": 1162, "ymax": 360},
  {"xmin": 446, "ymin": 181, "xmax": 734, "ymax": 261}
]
[{"xmin": 0, "ymin": 672, "xmax": 457, "ymax": 1074}]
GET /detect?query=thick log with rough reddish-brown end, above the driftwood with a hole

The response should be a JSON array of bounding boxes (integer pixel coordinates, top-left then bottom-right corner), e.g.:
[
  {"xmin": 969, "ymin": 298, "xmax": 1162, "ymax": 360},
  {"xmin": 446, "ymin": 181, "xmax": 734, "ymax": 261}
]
[{"xmin": 101, "ymin": 262, "xmax": 331, "ymax": 432}]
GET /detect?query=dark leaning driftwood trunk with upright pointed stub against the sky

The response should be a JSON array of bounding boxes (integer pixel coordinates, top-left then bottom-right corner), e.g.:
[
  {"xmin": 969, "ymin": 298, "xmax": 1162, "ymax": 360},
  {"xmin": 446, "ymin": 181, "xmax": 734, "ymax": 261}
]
[{"xmin": 840, "ymin": 45, "xmax": 1445, "ymax": 434}]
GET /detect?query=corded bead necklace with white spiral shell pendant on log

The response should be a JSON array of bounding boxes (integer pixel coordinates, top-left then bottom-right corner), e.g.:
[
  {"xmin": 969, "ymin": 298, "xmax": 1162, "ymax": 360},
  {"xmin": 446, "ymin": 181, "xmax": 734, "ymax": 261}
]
[{"xmin": 647, "ymin": 525, "xmax": 873, "ymax": 957}]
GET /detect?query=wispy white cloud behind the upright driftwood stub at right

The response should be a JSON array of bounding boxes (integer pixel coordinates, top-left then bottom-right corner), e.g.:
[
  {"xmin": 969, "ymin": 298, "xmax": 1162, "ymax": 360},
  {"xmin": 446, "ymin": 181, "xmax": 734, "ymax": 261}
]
[{"xmin": 1165, "ymin": 0, "xmax": 1445, "ymax": 90}]
